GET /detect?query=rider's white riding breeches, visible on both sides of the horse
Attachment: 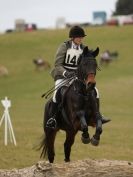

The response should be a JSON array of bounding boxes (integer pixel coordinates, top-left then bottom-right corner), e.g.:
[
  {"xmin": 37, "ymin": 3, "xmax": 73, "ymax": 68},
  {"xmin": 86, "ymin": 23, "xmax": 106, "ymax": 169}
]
[{"xmin": 53, "ymin": 79, "xmax": 99, "ymax": 103}]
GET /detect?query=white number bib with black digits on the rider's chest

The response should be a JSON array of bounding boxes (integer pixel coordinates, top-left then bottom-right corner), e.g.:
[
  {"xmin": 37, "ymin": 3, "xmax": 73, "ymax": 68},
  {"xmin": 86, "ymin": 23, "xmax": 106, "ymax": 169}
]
[{"xmin": 64, "ymin": 48, "xmax": 83, "ymax": 69}]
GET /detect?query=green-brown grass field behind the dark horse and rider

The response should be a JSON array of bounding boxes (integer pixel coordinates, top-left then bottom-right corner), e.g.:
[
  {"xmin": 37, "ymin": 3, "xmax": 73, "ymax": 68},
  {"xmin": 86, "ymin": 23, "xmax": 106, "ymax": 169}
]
[{"xmin": 0, "ymin": 26, "xmax": 133, "ymax": 169}]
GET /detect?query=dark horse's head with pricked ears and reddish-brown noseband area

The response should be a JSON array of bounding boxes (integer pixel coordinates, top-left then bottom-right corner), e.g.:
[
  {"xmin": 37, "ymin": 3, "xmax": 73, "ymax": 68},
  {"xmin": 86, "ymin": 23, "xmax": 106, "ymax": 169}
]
[{"xmin": 78, "ymin": 47, "xmax": 99, "ymax": 85}]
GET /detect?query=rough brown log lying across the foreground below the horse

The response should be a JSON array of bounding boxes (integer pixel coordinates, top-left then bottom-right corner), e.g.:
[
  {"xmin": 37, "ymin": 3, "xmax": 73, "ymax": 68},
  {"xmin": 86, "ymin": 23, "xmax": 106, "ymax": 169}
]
[{"xmin": 0, "ymin": 159, "xmax": 133, "ymax": 177}]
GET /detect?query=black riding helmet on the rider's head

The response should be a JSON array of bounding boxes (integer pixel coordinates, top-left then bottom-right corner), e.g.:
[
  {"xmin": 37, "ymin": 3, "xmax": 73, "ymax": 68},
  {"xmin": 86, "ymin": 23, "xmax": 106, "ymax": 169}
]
[{"xmin": 69, "ymin": 26, "xmax": 86, "ymax": 38}]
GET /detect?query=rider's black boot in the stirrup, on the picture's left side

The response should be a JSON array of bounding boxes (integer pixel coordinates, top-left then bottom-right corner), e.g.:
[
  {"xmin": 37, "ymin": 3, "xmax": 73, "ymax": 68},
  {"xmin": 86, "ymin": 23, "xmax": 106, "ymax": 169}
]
[{"xmin": 46, "ymin": 101, "xmax": 58, "ymax": 129}]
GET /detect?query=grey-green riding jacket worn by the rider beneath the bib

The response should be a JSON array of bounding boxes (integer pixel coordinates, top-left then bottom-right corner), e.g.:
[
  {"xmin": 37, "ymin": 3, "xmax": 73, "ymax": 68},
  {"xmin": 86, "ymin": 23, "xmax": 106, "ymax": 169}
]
[{"xmin": 51, "ymin": 40, "xmax": 85, "ymax": 80}]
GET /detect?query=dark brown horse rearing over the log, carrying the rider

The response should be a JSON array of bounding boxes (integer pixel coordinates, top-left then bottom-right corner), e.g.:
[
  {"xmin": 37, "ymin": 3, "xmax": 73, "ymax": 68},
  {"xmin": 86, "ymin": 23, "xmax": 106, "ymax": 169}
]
[{"xmin": 40, "ymin": 47, "xmax": 102, "ymax": 163}]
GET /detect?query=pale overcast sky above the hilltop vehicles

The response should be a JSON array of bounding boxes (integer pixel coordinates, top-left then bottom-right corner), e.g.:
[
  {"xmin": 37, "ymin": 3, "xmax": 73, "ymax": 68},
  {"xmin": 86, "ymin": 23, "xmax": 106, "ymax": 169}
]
[{"xmin": 0, "ymin": 0, "xmax": 117, "ymax": 31}]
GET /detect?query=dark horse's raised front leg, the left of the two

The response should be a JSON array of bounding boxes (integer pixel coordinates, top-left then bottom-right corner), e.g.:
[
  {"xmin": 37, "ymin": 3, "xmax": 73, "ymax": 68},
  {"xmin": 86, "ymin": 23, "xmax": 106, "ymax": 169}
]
[{"xmin": 77, "ymin": 111, "xmax": 90, "ymax": 144}]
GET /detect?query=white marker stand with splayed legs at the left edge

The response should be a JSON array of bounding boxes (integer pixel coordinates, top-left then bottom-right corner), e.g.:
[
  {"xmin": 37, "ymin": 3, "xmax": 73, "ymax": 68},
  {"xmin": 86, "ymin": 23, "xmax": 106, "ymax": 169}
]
[{"xmin": 0, "ymin": 97, "xmax": 17, "ymax": 146}]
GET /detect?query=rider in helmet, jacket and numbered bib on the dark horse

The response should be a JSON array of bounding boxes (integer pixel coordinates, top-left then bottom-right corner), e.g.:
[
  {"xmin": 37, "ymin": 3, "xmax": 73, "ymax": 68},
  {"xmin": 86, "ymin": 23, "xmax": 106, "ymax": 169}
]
[{"xmin": 46, "ymin": 26, "xmax": 110, "ymax": 128}]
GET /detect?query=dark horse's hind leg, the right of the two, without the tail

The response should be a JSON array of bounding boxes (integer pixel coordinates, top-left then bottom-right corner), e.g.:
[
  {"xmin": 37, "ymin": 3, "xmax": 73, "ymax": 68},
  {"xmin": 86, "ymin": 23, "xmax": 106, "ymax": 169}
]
[{"xmin": 64, "ymin": 132, "xmax": 76, "ymax": 162}]
